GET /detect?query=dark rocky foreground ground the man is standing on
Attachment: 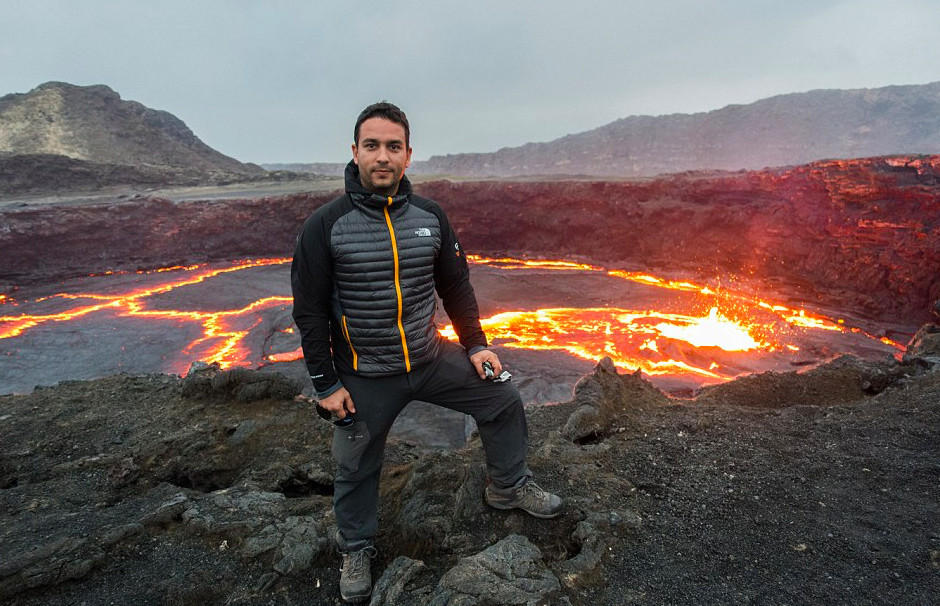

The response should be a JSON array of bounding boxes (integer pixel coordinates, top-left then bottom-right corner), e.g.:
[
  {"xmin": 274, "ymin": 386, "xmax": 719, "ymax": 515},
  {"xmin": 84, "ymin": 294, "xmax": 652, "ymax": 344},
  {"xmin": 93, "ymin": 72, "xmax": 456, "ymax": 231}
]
[{"xmin": 0, "ymin": 326, "xmax": 940, "ymax": 606}]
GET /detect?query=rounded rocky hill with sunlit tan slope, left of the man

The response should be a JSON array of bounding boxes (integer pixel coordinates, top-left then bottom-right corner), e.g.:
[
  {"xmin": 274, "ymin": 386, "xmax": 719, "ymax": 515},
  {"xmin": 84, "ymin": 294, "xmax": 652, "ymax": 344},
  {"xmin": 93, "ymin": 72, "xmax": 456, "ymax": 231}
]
[{"xmin": 0, "ymin": 82, "xmax": 265, "ymax": 191}]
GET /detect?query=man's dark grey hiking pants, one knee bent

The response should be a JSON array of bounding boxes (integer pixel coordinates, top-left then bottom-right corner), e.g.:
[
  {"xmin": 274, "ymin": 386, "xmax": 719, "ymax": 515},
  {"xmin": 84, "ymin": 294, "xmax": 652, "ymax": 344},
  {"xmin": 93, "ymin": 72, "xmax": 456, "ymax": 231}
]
[{"xmin": 333, "ymin": 341, "xmax": 529, "ymax": 551}]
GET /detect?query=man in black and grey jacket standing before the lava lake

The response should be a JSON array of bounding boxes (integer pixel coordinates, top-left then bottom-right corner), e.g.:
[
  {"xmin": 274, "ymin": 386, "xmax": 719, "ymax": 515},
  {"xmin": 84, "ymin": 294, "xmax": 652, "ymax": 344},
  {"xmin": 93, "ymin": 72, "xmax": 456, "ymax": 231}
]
[{"xmin": 291, "ymin": 102, "xmax": 562, "ymax": 602}]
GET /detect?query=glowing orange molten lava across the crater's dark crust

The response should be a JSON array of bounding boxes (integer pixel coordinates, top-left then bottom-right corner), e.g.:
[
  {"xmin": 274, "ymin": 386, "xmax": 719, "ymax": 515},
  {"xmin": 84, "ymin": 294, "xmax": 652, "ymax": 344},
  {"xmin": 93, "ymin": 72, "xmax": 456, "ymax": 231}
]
[{"xmin": 0, "ymin": 255, "xmax": 902, "ymax": 384}]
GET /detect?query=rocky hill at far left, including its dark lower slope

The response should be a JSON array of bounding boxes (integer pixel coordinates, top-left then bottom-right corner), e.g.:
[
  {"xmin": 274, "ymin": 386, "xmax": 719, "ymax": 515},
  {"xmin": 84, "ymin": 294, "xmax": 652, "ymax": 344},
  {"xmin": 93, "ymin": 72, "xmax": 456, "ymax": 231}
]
[{"xmin": 0, "ymin": 82, "xmax": 266, "ymax": 193}]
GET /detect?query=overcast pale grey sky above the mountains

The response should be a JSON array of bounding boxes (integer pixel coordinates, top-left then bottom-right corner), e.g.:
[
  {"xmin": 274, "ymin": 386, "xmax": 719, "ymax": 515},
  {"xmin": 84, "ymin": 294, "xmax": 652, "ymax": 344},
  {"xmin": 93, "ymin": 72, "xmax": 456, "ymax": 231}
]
[{"xmin": 0, "ymin": 0, "xmax": 940, "ymax": 163}]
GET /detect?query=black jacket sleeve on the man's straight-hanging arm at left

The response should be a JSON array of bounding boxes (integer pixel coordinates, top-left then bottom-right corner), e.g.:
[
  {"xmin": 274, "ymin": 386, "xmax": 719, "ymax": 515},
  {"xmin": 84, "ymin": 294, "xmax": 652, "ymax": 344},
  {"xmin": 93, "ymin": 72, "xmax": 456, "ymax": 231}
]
[{"xmin": 290, "ymin": 212, "xmax": 342, "ymax": 397}]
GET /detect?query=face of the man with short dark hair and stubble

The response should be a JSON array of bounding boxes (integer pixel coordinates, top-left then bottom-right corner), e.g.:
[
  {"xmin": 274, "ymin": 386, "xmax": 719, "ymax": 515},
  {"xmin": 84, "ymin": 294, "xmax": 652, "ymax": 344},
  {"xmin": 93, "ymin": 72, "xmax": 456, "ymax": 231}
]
[{"xmin": 352, "ymin": 117, "xmax": 411, "ymax": 196}]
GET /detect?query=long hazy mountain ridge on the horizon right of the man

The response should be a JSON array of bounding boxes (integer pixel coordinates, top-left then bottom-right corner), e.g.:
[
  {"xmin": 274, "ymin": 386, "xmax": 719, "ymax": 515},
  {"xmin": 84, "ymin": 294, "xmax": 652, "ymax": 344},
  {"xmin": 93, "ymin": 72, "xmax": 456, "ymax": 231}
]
[{"xmin": 413, "ymin": 82, "xmax": 940, "ymax": 177}]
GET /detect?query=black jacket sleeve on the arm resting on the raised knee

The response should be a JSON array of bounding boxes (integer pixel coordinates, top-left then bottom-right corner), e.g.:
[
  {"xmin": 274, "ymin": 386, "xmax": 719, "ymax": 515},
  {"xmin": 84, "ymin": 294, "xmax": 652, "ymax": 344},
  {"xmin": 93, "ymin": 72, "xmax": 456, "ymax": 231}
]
[{"xmin": 433, "ymin": 205, "xmax": 486, "ymax": 353}]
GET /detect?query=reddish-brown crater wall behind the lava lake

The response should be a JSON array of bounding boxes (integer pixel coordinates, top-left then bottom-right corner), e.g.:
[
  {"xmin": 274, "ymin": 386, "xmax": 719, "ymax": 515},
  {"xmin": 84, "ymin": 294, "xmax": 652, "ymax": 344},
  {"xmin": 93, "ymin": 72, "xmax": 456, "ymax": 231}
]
[{"xmin": 0, "ymin": 156, "xmax": 940, "ymax": 326}]
